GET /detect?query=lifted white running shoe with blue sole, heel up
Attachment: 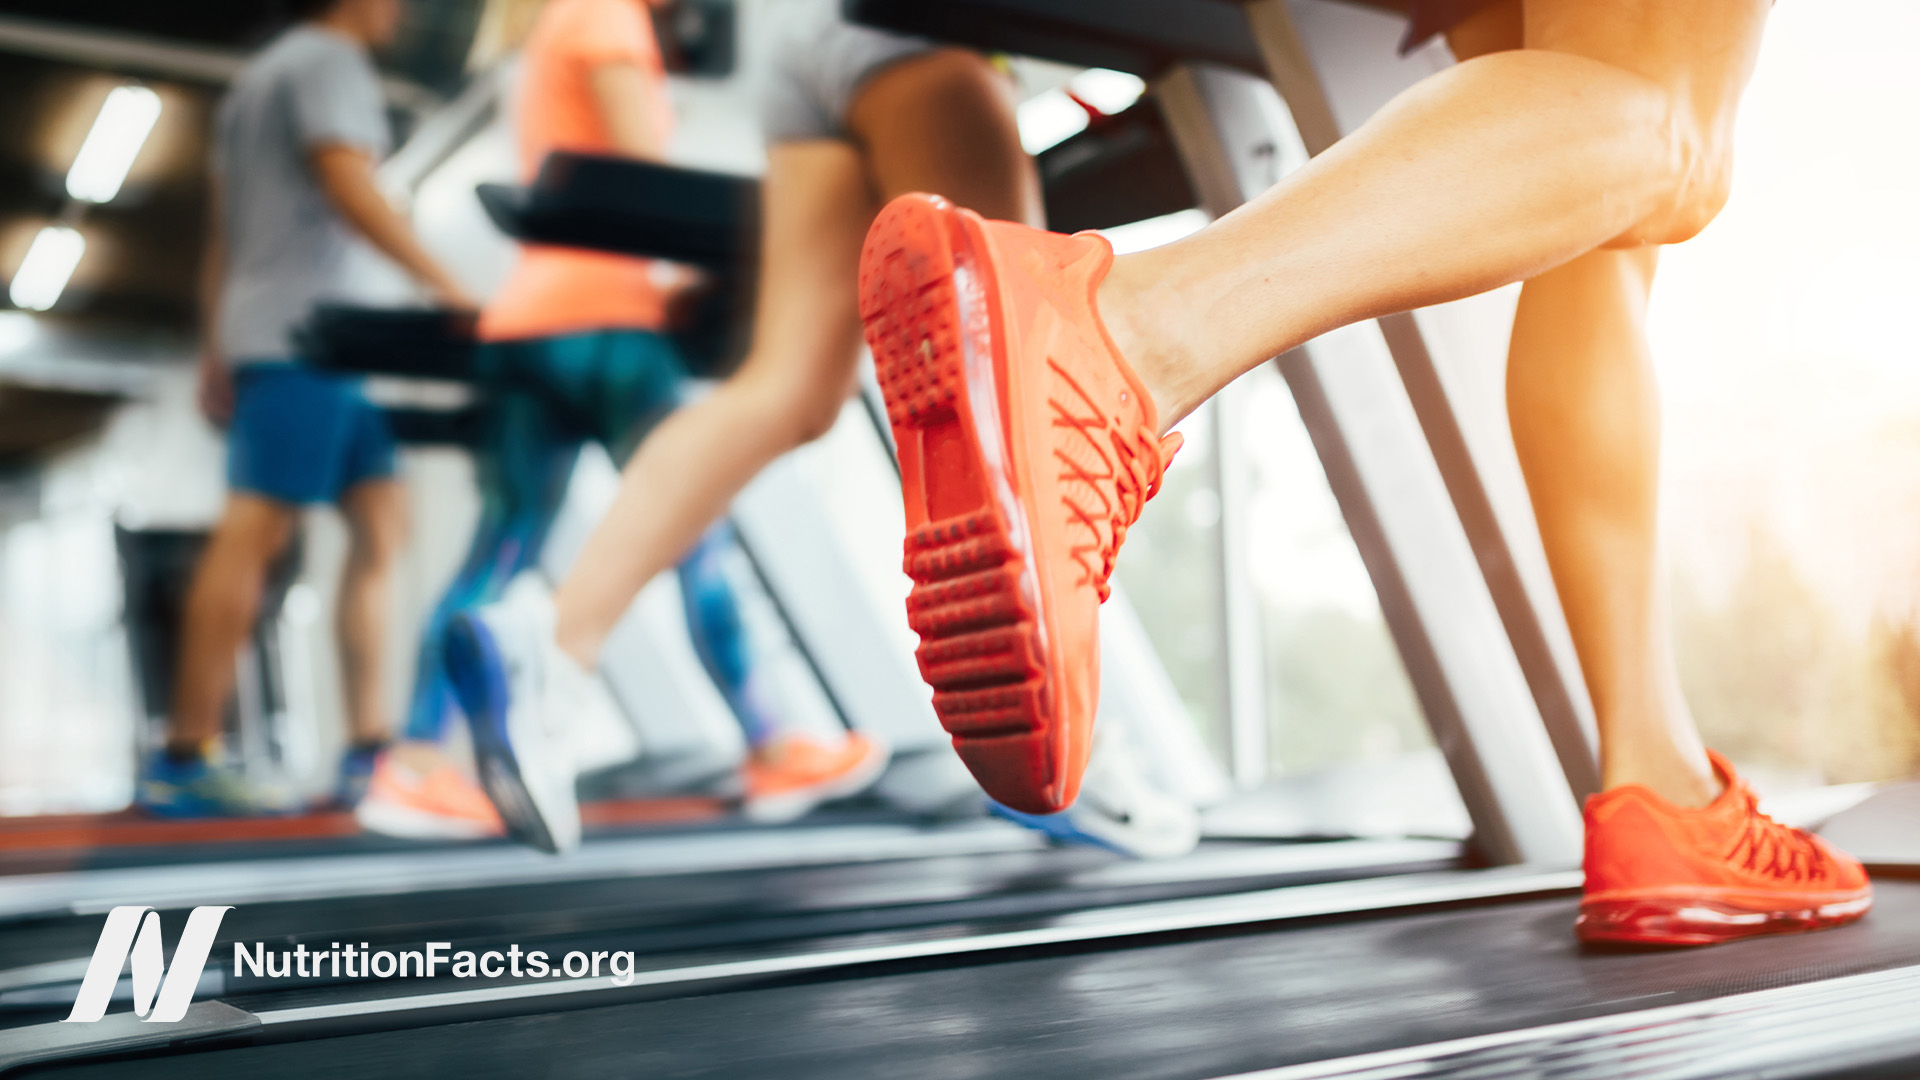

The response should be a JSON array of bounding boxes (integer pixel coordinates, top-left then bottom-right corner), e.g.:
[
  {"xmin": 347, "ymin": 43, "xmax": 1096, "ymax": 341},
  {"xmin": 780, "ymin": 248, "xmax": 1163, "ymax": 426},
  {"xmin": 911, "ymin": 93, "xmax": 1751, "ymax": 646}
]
[{"xmin": 442, "ymin": 573, "xmax": 624, "ymax": 851}]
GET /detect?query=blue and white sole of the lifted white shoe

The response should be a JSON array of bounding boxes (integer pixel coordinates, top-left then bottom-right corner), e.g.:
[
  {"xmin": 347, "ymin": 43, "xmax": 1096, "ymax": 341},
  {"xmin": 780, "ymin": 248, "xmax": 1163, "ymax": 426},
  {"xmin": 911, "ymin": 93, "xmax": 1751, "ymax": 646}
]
[{"xmin": 442, "ymin": 615, "xmax": 561, "ymax": 853}]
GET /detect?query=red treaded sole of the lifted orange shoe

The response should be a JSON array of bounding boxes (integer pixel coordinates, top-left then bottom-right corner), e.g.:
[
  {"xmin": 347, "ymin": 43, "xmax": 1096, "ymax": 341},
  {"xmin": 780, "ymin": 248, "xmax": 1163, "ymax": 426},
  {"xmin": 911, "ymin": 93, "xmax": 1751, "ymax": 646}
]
[{"xmin": 860, "ymin": 200, "xmax": 1066, "ymax": 813}]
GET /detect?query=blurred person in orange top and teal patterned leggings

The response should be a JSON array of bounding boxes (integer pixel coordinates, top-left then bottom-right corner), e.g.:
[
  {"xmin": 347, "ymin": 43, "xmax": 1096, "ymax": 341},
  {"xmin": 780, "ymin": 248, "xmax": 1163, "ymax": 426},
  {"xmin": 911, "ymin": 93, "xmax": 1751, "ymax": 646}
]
[{"xmin": 359, "ymin": 0, "xmax": 889, "ymax": 846}]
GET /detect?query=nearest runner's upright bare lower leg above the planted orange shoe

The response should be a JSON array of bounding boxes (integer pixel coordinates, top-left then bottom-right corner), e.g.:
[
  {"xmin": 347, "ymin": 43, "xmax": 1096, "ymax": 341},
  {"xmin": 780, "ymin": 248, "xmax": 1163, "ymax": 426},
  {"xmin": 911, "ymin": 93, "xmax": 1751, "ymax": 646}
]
[{"xmin": 1507, "ymin": 248, "xmax": 1718, "ymax": 805}]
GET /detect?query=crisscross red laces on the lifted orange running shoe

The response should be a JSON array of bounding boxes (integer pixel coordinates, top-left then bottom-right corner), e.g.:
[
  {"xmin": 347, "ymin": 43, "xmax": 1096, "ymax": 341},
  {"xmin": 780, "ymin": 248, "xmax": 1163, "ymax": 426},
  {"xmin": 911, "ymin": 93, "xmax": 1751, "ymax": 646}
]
[{"xmin": 1052, "ymin": 365, "xmax": 1171, "ymax": 603}]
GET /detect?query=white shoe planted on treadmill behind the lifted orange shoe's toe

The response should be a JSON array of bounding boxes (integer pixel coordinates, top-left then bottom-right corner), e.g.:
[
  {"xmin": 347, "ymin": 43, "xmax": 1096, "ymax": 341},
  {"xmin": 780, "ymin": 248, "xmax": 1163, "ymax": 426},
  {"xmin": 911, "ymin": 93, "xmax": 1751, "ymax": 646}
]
[{"xmin": 989, "ymin": 722, "xmax": 1200, "ymax": 859}]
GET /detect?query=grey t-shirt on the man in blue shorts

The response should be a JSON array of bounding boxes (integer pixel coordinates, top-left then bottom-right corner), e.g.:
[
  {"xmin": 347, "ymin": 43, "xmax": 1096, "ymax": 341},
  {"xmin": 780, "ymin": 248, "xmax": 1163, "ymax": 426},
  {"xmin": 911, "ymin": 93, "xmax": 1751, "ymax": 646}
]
[{"xmin": 213, "ymin": 25, "xmax": 388, "ymax": 361}]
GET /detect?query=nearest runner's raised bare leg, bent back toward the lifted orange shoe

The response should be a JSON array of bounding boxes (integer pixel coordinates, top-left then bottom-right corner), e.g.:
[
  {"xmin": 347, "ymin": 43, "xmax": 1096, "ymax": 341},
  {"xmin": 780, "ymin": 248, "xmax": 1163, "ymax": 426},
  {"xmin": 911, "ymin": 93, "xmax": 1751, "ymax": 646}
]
[{"xmin": 1100, "ymin": 0, "xmax": 1768, "ymax": 425}]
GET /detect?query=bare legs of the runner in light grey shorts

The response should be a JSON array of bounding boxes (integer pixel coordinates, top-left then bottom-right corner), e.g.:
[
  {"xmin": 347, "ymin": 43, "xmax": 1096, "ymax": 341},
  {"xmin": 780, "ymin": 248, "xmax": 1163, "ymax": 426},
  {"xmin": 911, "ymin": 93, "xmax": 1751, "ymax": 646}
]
[{"xmin": 553, "ymin": 50, "xmax": 1039, "ymax": 667}]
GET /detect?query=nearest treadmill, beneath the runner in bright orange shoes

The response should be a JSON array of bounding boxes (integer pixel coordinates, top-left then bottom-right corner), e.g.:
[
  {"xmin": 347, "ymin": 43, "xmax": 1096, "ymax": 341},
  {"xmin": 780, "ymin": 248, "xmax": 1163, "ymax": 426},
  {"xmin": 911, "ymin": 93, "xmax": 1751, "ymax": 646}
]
[{"xmin": 0, "ymin": 0, "xmax": 1920, "ymax": 1080}]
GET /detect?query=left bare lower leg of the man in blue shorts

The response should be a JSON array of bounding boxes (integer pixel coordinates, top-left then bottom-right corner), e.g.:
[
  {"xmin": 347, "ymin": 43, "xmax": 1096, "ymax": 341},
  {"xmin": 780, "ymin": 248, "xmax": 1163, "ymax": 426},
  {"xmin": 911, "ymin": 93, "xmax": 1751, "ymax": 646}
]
[{"xmin": 167, "ymin": 492, "xmax": 298, "ymax": 753}]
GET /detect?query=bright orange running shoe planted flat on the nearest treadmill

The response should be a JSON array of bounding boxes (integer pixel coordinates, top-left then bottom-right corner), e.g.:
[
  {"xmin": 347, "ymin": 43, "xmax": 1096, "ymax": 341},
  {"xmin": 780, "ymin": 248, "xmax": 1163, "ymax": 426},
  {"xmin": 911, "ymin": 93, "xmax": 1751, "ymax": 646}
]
[{"xmin": 1574, "ymin": 751, "xmax": 1874, "ymax": 945}]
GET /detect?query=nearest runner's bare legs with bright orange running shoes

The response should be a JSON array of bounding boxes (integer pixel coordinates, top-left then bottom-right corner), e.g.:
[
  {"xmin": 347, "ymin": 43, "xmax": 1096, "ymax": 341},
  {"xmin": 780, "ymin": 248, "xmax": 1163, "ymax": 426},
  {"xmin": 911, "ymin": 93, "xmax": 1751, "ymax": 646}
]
[{"xmin": 860, "ymin": 0, "xmax": 1872, "ymax": 944}]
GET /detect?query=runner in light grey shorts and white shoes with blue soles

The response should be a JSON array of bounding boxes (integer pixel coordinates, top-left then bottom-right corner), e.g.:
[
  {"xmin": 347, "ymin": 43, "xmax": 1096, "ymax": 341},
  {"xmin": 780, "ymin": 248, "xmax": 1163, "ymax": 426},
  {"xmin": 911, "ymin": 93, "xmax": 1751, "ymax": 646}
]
[{"xmin": 445, "ymin": 0, "xmax": 1198, "ymax": 855}]
